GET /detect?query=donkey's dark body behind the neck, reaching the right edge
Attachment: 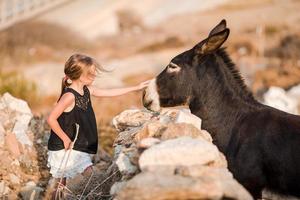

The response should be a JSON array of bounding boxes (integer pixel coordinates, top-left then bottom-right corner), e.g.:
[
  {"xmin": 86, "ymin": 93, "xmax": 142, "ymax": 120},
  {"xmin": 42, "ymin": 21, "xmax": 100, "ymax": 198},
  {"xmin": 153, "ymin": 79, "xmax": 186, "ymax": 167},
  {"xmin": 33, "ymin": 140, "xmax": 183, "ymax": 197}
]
[{"xmin": 230, "ymin": 106, "xmax": 300, "ymax": 197}]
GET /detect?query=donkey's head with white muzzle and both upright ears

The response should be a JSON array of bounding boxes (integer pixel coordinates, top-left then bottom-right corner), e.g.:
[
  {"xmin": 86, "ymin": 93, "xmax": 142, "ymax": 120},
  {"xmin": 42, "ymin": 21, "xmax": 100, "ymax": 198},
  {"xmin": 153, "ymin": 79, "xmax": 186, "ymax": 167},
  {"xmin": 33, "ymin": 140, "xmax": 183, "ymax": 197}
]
[{"xmin": 143, "ymin": 20, "xmax": 229, "ymax": 111}]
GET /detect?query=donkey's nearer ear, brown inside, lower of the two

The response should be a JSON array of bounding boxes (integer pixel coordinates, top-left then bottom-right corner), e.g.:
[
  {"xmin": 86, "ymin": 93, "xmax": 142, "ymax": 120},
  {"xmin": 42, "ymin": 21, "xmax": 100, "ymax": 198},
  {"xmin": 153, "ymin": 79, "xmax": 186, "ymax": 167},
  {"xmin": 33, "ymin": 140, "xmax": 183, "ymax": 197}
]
[{"xmin": 196, "ymin": 28, "xmax": 229, "ymax": 54}]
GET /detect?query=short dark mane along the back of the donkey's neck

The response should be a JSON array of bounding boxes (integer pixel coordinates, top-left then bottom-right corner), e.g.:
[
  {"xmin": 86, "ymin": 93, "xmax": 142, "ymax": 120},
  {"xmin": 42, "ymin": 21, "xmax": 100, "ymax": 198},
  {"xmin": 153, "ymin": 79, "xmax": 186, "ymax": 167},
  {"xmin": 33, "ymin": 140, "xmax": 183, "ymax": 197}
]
[{"xmin": 217, "ymin": 48, "xmax": 254, "ymax": 99}]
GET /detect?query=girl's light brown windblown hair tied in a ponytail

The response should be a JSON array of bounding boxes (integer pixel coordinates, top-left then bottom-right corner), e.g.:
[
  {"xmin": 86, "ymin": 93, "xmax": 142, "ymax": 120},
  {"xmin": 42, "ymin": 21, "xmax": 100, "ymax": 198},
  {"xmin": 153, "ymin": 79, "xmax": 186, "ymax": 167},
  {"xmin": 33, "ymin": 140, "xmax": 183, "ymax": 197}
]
[{"xmin": 60, "ymin": 54, "xmax": 106, "ymax": 97}]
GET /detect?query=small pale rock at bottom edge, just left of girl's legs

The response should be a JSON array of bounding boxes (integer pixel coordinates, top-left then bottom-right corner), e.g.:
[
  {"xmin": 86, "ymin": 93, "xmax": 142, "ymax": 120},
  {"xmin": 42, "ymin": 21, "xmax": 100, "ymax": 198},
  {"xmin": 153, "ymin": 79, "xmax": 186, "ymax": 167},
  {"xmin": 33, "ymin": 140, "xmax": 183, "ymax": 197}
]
[{"xmin": 20, "ymin": 181, "xmax": 44, "ymax": 200}]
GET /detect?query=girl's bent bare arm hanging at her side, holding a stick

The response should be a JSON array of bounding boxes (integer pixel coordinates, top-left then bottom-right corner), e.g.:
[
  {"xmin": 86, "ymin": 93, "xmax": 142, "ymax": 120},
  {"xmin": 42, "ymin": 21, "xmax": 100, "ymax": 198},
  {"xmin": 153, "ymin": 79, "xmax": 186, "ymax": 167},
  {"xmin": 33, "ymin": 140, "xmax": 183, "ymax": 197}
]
[{"xmin": 47, "ymin": 93, "xmax": 75, "ymax": 149}]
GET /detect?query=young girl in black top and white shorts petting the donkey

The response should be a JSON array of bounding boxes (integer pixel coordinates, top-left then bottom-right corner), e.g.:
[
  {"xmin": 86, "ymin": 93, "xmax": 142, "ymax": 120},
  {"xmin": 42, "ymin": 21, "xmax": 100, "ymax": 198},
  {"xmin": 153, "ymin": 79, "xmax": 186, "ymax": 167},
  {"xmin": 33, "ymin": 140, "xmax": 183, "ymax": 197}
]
[{"xmin": 47, "ymin": 54, "xmax": 148, "ymax": 197}]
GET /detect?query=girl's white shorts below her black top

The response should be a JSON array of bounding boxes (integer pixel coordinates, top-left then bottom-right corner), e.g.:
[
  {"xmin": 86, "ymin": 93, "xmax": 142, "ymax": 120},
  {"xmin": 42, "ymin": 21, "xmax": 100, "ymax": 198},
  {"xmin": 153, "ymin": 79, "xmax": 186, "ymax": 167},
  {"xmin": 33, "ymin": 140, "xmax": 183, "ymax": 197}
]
[{"xmin": 47, "ymin": 149, "xmax": 93, "ymax": 178}]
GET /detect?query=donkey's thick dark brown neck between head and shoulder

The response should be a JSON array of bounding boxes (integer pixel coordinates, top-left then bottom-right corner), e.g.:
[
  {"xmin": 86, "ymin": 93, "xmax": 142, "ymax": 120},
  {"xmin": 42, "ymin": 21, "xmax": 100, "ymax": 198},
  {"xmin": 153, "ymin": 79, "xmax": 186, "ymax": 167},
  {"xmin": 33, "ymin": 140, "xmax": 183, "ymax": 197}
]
[{"xmin": 189, "ymin": 50, "xmax": 260, "ymax": 152}]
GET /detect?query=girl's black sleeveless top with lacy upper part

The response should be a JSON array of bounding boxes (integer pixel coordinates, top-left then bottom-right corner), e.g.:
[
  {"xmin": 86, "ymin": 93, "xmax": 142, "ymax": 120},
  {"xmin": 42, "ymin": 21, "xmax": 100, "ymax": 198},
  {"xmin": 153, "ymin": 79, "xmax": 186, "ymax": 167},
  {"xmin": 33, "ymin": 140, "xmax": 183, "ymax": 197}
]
[{"xmin": 48, "ymin": 86, "xmax": 98, "ymax": 154}]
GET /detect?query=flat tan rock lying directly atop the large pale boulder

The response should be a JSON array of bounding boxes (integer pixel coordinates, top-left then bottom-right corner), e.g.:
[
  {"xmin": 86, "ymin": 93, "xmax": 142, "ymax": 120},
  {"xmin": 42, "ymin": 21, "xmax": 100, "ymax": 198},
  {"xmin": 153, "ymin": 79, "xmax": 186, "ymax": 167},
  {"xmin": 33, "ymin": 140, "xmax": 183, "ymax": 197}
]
[{"xmin": 161, "ymin": 123, "xmax": 212, "ymax": 142}]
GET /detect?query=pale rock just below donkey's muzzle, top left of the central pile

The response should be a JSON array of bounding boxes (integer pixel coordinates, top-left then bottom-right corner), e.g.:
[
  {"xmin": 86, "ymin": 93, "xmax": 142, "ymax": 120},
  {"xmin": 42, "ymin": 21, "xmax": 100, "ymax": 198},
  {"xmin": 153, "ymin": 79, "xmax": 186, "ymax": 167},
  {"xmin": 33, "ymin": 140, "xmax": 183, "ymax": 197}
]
[{"xmin": 113, "ymin": 109, "xmax": 152, "ymax": 131}]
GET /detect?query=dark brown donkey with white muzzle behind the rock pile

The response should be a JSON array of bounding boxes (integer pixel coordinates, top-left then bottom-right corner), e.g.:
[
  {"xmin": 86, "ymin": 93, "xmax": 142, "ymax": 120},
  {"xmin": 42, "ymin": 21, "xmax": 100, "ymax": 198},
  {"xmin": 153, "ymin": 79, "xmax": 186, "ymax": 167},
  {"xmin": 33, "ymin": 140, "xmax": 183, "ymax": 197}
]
[{"xmin": 143, "ymin": 20, "xmax": 300, "ymax": 198}]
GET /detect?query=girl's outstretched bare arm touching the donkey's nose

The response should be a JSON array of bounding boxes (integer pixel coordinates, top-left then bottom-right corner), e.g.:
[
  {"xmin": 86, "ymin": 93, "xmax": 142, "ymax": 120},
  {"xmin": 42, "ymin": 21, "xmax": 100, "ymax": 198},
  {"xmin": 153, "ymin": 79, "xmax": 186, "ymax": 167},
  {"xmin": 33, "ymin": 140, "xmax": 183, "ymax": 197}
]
[{"xmin": 88, "ymin": 80, "xmax": 150, "ymax": 97}]
